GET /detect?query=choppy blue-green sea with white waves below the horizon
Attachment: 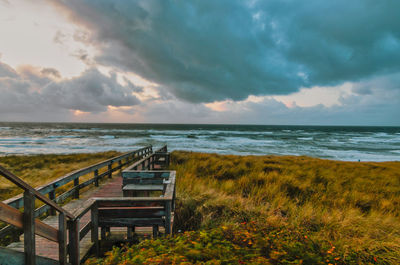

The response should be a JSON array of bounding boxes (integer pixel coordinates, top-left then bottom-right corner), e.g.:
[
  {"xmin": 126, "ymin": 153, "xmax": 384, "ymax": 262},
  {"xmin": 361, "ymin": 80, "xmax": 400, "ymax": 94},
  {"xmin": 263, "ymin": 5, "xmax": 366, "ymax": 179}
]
[{"xmin": 0, "ymin": 122, "xmax": 400, "ymax": 161}]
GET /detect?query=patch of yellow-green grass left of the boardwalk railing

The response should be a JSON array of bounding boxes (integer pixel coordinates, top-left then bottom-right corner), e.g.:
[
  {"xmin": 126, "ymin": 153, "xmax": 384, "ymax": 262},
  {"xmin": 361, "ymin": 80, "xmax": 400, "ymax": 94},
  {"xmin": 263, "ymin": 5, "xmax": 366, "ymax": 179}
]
[{"xmin": 0, "ymin": 152, "xmax": 120, "ymax": 201}]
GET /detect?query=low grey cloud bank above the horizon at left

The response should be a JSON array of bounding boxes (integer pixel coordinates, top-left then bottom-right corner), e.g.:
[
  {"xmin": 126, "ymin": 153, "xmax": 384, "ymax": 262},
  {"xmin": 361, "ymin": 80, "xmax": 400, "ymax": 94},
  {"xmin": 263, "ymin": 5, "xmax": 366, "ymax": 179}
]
[{"xmin": 0, "ymin": 62, "xmax": 141, "ymax": 121}]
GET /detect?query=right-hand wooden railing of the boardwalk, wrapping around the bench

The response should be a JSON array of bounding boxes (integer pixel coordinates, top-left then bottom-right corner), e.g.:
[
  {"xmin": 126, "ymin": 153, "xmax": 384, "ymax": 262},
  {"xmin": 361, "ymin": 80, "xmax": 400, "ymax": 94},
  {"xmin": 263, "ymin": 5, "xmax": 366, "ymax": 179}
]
[{"xmin": 59, "ymin": 146, "xmax": 176, "ymax": 264}]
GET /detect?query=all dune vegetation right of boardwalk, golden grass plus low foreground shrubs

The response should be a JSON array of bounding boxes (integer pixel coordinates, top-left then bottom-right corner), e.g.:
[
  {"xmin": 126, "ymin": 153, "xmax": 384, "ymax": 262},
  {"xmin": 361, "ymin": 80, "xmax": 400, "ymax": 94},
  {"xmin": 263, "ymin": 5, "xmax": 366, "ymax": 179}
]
[{"xmin": 88, "ymin": 152, "xmax": 400, "ymax": 264}]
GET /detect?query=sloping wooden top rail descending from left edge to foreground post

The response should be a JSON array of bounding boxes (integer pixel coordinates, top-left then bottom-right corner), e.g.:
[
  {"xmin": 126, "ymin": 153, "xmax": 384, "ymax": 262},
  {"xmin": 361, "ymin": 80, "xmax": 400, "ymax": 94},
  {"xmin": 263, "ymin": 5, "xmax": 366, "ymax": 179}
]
[{"xmin": 0, "ymin": 166, "xmax": 74, "ymax": 219}]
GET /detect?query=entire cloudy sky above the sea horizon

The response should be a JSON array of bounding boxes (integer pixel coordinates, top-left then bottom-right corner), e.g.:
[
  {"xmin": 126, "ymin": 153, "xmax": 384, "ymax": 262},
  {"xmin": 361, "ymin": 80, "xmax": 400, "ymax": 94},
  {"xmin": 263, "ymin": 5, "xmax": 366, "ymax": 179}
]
[{"xmin": 0, "ymin": 0, "xmax": 400, "ymax": 126}]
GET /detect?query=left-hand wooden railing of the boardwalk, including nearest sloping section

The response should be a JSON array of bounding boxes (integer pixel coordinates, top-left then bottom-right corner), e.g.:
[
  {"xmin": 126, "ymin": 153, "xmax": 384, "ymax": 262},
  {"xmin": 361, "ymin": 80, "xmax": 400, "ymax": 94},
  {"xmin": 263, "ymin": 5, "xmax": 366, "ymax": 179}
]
[{"xmin": 0, "ymin": 146, "xmax": 152, "ymax": 265}]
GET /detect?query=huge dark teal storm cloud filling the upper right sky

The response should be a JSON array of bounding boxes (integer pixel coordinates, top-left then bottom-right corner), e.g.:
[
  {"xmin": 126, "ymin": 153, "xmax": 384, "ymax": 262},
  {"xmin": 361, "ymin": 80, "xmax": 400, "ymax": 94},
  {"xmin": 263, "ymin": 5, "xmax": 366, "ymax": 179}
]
[{"xmin": 52, "ymin": 0, "xmax": 400, "ymax": 102}]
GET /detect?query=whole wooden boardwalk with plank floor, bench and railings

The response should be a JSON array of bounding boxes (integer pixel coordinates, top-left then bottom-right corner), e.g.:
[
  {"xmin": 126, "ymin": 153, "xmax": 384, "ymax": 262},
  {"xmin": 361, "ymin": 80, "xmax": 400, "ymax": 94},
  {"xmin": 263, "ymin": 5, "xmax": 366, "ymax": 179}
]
[{"xmin": 0, "ymin": 146, "xmax": 175, "ymax": 264}]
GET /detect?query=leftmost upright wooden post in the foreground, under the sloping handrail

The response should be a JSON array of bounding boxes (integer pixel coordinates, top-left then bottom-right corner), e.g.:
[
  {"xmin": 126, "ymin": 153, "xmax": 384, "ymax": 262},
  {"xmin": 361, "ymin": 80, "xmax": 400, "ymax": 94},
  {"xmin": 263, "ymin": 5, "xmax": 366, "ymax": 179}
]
[{"xmin": 23, "ymin": 190, "xmax": 36, "ymax": 265}]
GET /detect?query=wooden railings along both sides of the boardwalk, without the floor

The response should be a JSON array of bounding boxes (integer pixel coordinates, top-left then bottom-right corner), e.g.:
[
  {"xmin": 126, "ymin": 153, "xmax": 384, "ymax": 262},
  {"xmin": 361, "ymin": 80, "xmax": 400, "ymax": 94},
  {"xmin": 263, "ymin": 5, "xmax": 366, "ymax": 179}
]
[{"xmin": 0, "ymin": 145, "xmax": 169, "ymax": 265}]
